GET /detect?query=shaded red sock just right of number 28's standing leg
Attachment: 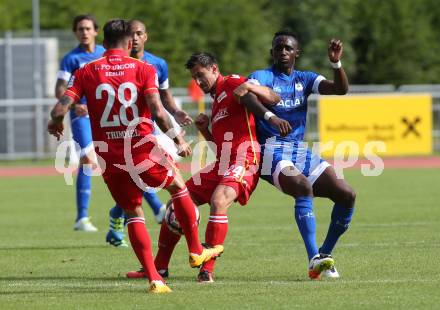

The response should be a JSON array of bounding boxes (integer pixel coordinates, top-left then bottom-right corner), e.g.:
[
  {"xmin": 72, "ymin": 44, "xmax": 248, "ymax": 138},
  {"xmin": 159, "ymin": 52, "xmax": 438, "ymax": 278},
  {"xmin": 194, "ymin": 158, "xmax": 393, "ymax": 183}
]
[{"xmin": 154, "ymin": 221, "xmax": 180, "ymax": 270}]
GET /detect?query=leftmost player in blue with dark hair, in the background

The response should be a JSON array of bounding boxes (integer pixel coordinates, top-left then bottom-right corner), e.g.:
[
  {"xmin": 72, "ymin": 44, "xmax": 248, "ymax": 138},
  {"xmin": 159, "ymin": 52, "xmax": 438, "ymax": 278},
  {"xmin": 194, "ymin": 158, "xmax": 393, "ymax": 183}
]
[{"xmin": 55, "ymin": 15, "xmax": 105, "ymax": 232}]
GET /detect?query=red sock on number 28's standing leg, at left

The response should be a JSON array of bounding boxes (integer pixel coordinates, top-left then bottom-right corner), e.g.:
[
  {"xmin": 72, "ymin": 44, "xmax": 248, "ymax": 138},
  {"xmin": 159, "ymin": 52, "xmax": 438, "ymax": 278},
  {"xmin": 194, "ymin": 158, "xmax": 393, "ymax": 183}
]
[{"xmin": 127, "ymin": 217, "xmax": 163, "ymax": 282}]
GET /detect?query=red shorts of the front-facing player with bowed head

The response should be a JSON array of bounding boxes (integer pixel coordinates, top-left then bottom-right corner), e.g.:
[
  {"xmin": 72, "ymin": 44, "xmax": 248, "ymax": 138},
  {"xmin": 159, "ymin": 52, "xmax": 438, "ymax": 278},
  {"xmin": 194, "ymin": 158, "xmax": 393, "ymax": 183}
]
[{"xmin": 186, "ymin": 161, "xmax": 259, "ymax": 206}]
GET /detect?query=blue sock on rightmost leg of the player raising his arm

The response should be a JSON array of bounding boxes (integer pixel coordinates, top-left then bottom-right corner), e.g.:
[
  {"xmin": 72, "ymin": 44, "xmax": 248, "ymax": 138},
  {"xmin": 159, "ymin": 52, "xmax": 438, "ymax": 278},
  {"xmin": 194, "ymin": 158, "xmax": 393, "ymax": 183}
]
[{"xmin": 319, "ymin": 203, "xmax": 354, "ymax": 254}]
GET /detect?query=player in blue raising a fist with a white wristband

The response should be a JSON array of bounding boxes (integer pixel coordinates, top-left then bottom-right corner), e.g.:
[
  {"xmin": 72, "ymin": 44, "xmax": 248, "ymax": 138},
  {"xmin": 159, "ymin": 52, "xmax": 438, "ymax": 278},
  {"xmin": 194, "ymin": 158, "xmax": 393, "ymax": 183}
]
[{"xmin": 250, "ymin": 31, "xmax": 356, "ymax": 279}]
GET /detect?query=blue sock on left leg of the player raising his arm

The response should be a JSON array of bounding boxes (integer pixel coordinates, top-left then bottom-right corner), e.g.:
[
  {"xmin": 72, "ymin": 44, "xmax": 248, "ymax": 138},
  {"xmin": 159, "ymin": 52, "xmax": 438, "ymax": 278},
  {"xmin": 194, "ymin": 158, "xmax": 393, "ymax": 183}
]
[{"xmin": 295, "ymin": 196, "xmax": 318, "ymax": 260}]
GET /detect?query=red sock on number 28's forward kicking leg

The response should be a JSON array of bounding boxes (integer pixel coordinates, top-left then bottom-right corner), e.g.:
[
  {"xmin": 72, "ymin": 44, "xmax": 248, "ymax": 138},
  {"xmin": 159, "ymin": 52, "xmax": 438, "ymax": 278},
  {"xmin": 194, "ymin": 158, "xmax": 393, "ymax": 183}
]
[{"xmin": 171, "ymin": 188, "xmax": 203, "ymax": 254}]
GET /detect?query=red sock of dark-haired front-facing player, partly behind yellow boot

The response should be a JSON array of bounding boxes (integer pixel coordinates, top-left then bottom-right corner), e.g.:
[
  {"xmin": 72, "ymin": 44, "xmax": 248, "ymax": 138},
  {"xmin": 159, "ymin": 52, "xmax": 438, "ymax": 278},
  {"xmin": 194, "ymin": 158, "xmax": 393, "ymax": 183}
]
[{"xmin": 202, "ymin": 214, "xmax": 228, "ymax": 272}]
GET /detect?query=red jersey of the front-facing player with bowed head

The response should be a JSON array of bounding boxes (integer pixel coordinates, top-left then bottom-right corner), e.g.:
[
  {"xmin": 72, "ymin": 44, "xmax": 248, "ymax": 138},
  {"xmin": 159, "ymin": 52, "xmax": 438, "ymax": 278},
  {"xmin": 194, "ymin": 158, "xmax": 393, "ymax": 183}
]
[{"xmin": 211, "ymin": 75, "xmax": 260, "ymax": 164}]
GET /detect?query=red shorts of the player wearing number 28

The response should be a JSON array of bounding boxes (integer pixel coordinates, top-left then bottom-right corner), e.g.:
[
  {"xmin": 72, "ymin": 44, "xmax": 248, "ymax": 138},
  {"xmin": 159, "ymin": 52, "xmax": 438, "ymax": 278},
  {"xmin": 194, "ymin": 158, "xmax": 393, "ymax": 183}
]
[{"xmin": 103, "ymin": 148, "xmax": 177, "ymax": 210}]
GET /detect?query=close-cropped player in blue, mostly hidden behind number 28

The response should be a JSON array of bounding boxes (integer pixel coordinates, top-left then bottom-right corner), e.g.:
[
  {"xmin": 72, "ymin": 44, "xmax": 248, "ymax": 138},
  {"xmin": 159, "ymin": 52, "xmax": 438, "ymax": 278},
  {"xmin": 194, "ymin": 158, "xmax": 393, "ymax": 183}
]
[{"xmin": 106, "ymin": 20, "xmax": 192, "ymax": 247}]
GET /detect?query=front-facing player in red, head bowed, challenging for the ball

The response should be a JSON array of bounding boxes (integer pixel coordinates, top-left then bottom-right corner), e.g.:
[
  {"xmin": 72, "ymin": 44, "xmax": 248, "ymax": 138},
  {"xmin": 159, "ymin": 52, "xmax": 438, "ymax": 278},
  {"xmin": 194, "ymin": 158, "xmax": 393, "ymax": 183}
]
[{"xmin": 127, "ymin": 53, "xmax": 290, "ymax": 282}]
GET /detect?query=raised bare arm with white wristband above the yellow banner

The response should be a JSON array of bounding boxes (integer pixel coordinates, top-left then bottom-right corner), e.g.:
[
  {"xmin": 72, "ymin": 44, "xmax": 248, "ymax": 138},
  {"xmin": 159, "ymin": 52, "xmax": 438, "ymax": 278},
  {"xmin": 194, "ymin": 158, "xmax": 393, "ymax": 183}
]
[{"xmin": 319, "ymin": 39, "xmax": 348, "ymax": 95}]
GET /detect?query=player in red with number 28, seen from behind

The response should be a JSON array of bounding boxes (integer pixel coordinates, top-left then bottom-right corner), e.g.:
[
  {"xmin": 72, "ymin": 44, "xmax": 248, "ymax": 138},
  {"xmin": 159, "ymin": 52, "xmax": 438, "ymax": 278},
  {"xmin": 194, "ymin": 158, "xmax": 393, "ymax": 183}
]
[{"xmin": 48, "ymin": 19, "xmax": 223, "ymax": 293}]
